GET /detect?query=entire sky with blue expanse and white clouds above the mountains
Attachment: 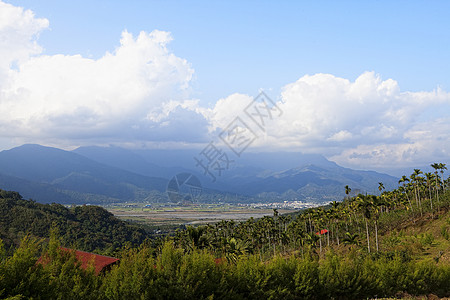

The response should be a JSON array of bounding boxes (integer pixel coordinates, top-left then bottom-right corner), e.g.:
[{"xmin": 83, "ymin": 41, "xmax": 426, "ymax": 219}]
[{"xmin": 0, "ymin": 0, "xmax": 450, "ymax": 170}]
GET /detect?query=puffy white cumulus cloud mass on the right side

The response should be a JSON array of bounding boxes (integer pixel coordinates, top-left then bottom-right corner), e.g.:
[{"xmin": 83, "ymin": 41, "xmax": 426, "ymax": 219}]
[{"xmin": 210, "ymin": 72, "xmax": 450, "ymax": 168}]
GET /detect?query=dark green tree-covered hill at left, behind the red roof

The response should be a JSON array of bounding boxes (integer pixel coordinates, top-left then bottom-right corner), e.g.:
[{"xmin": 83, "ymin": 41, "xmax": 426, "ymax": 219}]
[{"xmin": 0, "ymin": 190, "xmax": 147, "ymax": 253}]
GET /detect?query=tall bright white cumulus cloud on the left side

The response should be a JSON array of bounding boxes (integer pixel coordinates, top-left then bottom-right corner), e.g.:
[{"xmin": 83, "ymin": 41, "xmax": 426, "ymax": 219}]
[{"xmin": 0, "ymin": 2, "xmax": 207, "ymax": 145}]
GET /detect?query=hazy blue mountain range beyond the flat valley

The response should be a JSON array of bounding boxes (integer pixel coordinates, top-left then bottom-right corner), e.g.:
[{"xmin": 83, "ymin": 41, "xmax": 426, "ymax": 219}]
[{"xmin": 0, "ymin": 144, "xmax": 398, "ymax": 204}]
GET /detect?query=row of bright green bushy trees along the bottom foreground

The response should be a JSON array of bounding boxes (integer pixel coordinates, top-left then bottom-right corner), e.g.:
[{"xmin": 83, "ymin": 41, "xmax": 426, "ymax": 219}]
[{"xmin": 0, "ymin": 237, "xmax": 450, "ymax": 300}]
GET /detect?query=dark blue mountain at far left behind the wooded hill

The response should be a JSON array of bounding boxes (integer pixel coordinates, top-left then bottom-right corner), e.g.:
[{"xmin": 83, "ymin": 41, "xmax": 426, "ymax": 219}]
[{"xmin": 0, "ymin": 145, "xmax": 167, "ymax": 203}]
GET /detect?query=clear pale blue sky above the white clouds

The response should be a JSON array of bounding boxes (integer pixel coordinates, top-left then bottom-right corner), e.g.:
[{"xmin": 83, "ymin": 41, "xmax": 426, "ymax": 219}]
[{"xmin": 9, "ymin": 0, "xmax": 450, "ymax": 102}]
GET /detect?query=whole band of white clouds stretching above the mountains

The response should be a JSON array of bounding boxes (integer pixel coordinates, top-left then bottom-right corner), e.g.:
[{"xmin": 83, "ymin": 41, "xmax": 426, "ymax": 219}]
[{"xmin": 0, "ymin": 2, "xmax": 450, "ymax": 168}]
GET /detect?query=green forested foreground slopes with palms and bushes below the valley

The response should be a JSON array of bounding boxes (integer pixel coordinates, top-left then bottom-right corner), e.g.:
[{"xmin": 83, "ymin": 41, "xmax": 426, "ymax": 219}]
[{"xmin": 0, "ymin": 164, "xmax": 450, "ymax": 299}]
